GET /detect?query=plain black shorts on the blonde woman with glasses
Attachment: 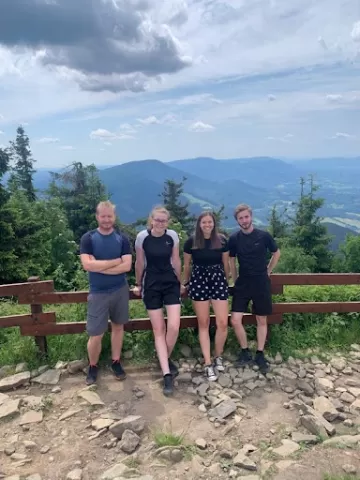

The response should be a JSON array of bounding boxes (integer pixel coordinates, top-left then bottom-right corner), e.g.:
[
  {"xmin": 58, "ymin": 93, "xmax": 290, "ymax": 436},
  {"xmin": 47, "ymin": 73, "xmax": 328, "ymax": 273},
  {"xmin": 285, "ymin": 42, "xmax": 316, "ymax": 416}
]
[{"xmin": 142, "ymin": 274, "xmax": 181, "ymax": 310}]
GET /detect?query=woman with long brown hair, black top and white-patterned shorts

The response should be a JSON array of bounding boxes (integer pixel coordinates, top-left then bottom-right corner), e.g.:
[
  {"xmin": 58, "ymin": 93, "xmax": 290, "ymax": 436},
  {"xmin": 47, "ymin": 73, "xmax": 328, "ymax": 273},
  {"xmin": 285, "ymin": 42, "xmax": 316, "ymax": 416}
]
[{"xmin": 184, "ymin": 212, "xmax": 229, "ymax": 381}]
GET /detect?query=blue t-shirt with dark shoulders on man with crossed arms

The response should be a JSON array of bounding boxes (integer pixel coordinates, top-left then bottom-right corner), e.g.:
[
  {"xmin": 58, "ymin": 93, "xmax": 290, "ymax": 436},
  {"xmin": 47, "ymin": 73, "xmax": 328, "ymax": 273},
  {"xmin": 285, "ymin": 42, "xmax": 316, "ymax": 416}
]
[{"xmin": 80, "ymin": 230, "xmax": 131, "ymax": 293}]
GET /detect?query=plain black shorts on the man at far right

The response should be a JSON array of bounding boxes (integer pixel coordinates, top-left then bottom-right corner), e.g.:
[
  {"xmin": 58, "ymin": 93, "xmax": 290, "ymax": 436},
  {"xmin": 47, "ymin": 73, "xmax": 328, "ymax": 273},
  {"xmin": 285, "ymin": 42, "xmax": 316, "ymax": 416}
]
[{"xmin": 231, "ymin": 275, "xmax": 272, "ymax": 317}]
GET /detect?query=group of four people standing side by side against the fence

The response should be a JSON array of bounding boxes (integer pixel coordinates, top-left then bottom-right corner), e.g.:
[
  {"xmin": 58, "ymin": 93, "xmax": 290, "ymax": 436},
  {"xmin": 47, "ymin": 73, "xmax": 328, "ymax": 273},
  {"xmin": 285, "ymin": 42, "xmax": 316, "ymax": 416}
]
[{"xmin": 80, "ymin": 202, "xmax": 280, "ymax": 395}]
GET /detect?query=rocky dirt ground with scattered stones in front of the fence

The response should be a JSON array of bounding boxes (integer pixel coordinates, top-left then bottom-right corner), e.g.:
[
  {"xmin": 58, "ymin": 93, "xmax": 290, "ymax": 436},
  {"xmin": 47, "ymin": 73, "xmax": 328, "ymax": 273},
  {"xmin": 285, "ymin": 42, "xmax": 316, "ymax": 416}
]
[{"xmin": 0, "ymin": 345, "xmax": 360, "ymax": 480}]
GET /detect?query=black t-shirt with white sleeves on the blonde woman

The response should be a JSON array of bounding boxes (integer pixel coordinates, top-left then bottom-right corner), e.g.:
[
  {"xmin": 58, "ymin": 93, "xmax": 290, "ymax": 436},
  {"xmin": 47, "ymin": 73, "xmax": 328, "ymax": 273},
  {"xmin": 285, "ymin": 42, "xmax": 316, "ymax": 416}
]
[{"xmin": 135, "ymin": 230, "xmax": 179, "ymax": 275}]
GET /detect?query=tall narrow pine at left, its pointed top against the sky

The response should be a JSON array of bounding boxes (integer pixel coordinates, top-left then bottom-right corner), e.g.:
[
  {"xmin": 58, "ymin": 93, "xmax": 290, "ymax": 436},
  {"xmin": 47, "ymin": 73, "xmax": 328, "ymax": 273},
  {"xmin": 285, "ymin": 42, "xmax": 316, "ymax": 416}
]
[{"xmin": 9, "ymin": 126, "xmax": 36, "ymax": 202}]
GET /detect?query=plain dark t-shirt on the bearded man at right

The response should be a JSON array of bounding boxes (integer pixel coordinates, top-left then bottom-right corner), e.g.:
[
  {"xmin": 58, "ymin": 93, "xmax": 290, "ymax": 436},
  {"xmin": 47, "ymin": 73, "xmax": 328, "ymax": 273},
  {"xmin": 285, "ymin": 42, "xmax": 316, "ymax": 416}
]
[{"xmin": 229, "ymin": 228, "xmax": 278, "ymax": 277}]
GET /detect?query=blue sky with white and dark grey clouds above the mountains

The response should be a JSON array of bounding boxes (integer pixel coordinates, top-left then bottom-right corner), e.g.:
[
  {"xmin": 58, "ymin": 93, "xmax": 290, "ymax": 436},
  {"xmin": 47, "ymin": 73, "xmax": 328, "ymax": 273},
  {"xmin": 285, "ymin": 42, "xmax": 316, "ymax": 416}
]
[{"xmin": 0, "ymin": 0, "xmax": 360, "ymax": 167}]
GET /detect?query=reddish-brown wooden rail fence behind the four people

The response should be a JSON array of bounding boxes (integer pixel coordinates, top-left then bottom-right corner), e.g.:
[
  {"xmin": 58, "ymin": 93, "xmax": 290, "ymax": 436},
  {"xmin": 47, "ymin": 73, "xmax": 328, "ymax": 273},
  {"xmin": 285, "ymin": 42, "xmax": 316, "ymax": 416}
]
[{"xmin": 0, "ymin": 273, "xmax": 360, "ymax": 354}]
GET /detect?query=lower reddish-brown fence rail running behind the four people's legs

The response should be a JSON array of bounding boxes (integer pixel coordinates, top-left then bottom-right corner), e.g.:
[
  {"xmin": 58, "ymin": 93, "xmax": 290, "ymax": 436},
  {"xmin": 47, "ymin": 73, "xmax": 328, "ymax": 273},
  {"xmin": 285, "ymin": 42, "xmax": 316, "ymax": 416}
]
[{"xmin": 20, "ymin": 314, "xmax": 282, "ymax": 336}]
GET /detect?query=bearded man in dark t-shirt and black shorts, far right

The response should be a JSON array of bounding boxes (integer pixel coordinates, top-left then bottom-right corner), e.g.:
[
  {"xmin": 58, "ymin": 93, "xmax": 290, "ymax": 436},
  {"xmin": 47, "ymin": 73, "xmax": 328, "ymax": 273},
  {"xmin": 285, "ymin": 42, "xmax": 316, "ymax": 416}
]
[{"xmin": 229, "ymin": 204, "xmax": 280, "ymax": 373}]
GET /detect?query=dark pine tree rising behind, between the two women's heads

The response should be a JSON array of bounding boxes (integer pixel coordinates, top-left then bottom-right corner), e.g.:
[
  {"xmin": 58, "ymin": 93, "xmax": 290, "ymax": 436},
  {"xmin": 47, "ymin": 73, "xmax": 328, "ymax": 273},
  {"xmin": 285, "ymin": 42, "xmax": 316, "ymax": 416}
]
[{"xmin": 160, "ymin": 177, "xmax": 195, "ymax": 233}]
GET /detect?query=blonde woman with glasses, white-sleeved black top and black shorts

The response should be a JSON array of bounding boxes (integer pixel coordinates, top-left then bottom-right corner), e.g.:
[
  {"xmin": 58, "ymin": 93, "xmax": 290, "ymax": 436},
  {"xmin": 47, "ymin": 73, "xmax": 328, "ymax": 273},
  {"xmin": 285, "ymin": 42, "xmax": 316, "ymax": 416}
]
[{"xmin": 134, "ymin": 206, "xmax": 182, "ymax": 395}]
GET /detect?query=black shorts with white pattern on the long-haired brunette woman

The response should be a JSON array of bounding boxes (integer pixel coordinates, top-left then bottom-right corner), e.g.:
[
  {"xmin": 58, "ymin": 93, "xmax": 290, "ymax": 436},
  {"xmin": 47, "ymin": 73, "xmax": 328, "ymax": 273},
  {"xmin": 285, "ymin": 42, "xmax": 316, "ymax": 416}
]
[{"xmin": 189, "ymin": 265, "xmax": 229, "ymax": 302}]
